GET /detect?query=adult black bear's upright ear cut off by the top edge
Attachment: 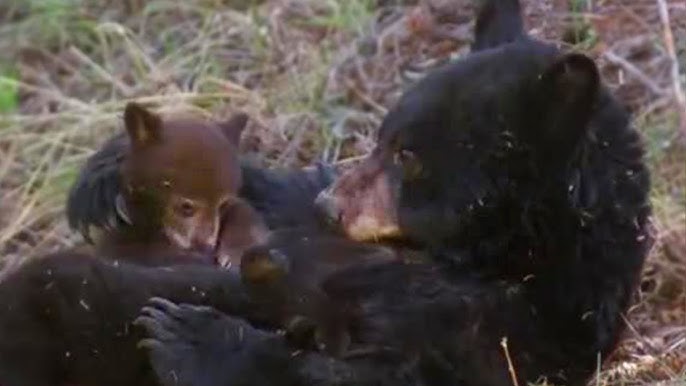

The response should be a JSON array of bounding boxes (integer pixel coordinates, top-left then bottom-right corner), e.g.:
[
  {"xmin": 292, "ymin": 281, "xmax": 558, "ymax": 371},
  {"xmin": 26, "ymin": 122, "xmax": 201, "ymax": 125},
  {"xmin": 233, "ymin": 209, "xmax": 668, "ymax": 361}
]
[{"xmin": 472, "ymin": 0, "xmax": 524, "ymax": 51}]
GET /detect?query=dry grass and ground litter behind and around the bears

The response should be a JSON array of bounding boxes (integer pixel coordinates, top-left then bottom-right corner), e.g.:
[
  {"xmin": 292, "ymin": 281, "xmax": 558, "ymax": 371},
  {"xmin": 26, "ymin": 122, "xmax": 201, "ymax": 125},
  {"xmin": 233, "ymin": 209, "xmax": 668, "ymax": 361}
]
[{"xmin": 0, "ymin": 0, "xmax": 686, "ymax": 385}]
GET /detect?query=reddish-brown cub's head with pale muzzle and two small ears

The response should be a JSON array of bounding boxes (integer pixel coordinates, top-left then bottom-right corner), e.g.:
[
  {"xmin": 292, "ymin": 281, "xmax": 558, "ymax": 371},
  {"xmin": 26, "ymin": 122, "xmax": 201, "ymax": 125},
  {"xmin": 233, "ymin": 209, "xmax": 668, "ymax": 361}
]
[{"xmin": 117, "ymin": 103, "xmax": 247, "ymax": 252}]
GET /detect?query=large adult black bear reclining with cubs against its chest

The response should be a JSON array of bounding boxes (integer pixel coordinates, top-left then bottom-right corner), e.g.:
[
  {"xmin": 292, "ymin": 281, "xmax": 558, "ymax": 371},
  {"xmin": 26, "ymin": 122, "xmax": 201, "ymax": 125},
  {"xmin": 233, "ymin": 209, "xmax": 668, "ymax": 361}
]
[{"xmin": 136, "ymin": 0, "xmax": 652, "ymax": 386}]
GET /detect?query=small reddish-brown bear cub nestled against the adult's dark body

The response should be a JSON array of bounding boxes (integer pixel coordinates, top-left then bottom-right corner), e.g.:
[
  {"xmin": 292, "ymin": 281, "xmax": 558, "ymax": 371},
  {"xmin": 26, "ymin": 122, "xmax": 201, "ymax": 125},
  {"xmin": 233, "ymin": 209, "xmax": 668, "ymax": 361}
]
[{"xmin": 82, "ymin": 103, "xmax": 265, "ymax": 264}]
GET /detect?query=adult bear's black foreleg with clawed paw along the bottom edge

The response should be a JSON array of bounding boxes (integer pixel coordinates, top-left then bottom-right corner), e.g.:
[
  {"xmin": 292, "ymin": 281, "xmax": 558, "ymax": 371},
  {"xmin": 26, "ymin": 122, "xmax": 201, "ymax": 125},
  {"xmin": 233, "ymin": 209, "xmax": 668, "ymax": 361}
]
[{"xmin": 136, "ymin": 298, "xmax": 425, "ymax": 386}]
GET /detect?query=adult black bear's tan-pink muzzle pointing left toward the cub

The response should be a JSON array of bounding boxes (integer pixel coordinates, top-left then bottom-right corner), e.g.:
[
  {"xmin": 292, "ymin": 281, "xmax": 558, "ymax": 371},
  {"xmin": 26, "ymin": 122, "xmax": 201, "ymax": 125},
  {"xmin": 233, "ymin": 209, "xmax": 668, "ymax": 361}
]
[{"xmin": 316, "ymin": 154, "xmax": 403, "ymax": 241}]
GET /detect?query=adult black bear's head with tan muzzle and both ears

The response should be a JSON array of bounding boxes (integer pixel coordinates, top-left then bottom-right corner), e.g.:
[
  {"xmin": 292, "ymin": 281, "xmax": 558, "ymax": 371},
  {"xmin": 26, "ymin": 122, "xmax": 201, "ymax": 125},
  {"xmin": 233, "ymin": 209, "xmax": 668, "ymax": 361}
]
[{"xmin": 318, "ymin": 1, "xmax": 648, "ymax": 266}]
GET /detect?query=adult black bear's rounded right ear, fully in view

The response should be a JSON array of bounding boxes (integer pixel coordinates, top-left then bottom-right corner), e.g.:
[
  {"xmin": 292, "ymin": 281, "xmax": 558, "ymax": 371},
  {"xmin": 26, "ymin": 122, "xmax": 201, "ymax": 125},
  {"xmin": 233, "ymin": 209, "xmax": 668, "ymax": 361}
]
[{"xmin": 533, "ymin": 54, "xmax": 600, "ymax": 157}]
